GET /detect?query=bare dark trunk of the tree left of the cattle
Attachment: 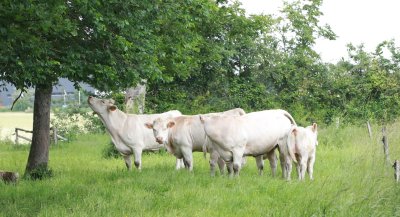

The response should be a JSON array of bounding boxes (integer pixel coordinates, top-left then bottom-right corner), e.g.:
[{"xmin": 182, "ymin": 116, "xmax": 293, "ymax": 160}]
[{"xmin": 25, "ymin": 84, "xmax": 52, "ymax": 178}]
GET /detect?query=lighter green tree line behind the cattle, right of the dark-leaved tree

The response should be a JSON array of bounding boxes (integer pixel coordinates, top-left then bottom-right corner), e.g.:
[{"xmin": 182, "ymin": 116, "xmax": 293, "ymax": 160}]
[{"xmin": 147, "ymin": 1, "xmax": 399, "ymax": 124}]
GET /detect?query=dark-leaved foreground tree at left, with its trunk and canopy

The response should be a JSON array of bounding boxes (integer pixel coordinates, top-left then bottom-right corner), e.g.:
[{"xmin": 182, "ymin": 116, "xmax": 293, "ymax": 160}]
[{"xmin": 0, "ymin": 0, "xmax": 200, "ymax": 178}]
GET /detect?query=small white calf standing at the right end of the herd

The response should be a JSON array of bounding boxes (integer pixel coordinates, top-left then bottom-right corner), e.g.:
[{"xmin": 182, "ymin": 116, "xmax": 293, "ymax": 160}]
[{"xmin": 287, "ymin": 123, "xmax": 318, "ymax": 180}]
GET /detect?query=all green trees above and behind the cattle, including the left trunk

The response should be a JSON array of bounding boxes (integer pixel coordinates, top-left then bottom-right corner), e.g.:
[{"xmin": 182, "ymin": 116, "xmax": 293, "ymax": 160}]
[{"xmin": 0, "ymin": 0, "xmax": 400, "ymax": 176}]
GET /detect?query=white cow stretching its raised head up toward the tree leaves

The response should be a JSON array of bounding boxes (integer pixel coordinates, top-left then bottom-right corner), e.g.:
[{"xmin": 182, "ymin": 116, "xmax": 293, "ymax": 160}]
[{"xmin": 88, "ymin": 96, "xmax": 182, "ymax": 170}]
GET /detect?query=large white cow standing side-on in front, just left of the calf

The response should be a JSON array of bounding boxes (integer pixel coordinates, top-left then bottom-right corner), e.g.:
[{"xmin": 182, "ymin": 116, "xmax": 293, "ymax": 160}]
[{"xmin": 200, "ymin": 110, "xmax": 296, "ymax": 177}]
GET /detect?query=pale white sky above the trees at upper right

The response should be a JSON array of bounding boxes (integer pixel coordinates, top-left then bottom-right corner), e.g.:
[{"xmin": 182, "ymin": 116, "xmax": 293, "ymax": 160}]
[{"xmin": 240, "ymin": 0, "xmax": 400, "ymax": 63}]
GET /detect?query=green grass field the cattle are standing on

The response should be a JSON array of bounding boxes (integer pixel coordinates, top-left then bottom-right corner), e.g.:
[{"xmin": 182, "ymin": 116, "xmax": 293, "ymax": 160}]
[{"xmin": 0, "ymin": 121, "xmax": 400, "ymax": 217}]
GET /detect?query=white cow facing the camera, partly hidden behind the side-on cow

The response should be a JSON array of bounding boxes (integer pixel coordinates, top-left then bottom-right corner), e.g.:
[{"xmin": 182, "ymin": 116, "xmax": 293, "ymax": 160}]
[{"xmin": 146, "ymin": 108, "xmax": 246, "ymax": 176}]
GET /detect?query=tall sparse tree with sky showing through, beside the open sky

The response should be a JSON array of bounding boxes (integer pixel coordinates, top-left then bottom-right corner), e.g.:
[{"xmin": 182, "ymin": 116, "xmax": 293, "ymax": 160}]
[{"xmin": 253, "ymin": 0, "xmax": 336, "ymax": 123}]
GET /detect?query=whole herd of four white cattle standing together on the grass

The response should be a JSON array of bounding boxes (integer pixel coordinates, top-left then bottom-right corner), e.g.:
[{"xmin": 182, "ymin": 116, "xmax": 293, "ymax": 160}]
[{"xmin": 88, "ymin": 96, "xmax": 318, "ymax": 180}]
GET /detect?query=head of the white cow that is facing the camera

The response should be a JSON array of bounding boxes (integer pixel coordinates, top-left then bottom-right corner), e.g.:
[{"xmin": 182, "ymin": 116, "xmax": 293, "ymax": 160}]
[{"xmin": 145, "ymin": 118, "xmax": 175, "ymax": 144}]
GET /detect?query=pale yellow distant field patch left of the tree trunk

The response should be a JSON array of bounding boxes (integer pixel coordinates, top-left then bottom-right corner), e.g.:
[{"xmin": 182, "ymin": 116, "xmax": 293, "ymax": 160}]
[{"xmin": 0, "ymin": 112, "xmax": 33, "ymax": 141}]
